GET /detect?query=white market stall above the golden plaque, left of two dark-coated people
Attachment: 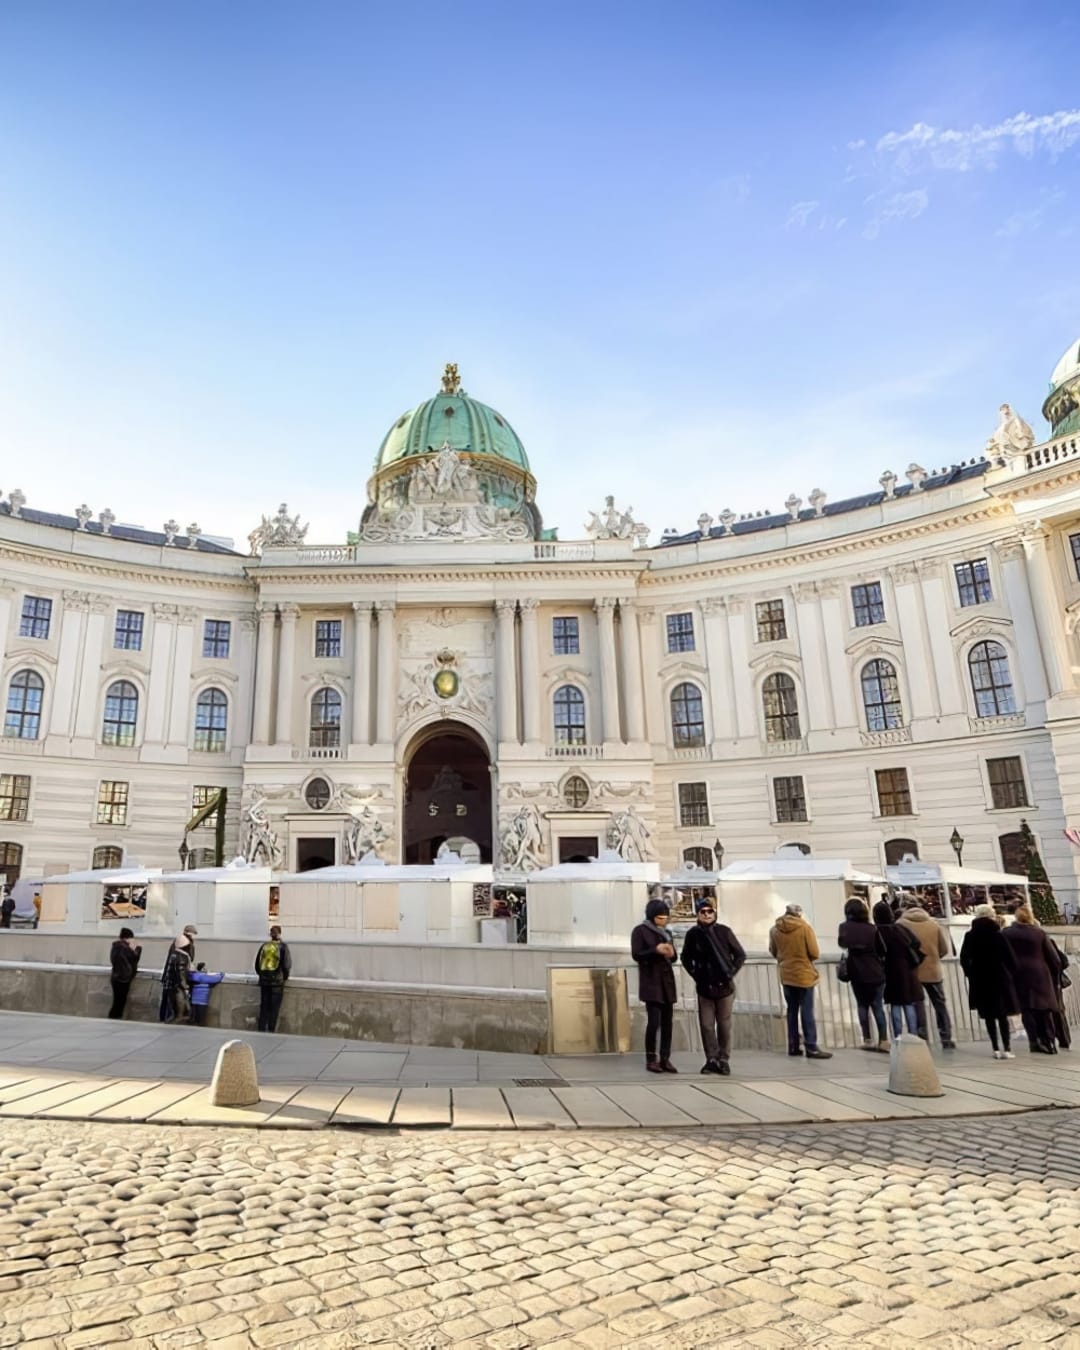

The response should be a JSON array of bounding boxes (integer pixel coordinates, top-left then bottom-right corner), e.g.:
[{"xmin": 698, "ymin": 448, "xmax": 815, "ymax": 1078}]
[{"xmin": 525, "ymin": 852, "xmax": 660, "ymax": 950}]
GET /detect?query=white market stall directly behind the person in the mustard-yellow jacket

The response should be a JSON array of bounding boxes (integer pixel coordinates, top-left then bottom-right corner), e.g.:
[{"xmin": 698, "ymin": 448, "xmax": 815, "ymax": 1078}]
[{"xmin": 717, "ymin": 848, "xmax": 886, "ymax": 956}]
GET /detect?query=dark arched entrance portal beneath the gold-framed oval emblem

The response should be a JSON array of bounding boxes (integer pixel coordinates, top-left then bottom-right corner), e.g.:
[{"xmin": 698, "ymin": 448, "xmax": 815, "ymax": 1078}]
[{"xmin": 402, "ymin": 724, "xmax": 491, "ymax": 863}]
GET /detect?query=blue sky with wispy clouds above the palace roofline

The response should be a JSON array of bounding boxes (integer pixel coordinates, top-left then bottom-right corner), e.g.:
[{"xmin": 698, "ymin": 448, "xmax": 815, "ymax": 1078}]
[{"xmin": 0, "ymin": 0, "xmax": 1080, "ymax": 543}]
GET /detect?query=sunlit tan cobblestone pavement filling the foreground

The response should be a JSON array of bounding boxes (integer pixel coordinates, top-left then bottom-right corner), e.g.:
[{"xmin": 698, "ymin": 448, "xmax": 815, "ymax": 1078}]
[{"xmin": 0, "ymin": 1111, "xmax": 1080, "ymax": 1350}]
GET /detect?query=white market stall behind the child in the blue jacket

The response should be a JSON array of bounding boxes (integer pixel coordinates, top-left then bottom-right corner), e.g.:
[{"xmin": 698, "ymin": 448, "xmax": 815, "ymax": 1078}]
[{"xmin": 143, "ymin": 857, "xmax": 274, "ymax": 940}]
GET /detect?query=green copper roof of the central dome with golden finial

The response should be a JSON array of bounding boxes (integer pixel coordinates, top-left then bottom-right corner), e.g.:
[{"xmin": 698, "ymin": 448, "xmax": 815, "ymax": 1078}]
[{"xmin": 375, "ymin": 366, "xmax": 529, "ymax": 474}]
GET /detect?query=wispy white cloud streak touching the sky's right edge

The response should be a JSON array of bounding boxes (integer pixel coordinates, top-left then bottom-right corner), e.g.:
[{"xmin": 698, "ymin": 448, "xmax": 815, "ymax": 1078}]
[{"xmin": 874, "ymin": 108, "xmax": 1080, "ymax": 173}]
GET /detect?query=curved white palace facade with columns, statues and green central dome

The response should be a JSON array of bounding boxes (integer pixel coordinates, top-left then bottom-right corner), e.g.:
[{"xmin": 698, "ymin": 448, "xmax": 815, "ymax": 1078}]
[{"xmin": 0, "ymin": 353, "xmax": 1080, "ymax": 905}]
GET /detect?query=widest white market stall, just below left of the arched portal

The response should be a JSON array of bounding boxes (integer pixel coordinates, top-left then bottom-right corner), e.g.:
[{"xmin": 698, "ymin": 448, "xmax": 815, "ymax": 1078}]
[{"xmin": 278, "ymin": 857, "xmax": 493, "ymax": 942}]
